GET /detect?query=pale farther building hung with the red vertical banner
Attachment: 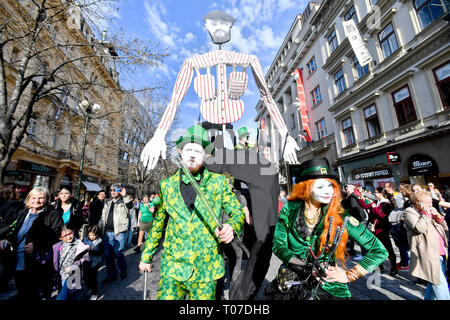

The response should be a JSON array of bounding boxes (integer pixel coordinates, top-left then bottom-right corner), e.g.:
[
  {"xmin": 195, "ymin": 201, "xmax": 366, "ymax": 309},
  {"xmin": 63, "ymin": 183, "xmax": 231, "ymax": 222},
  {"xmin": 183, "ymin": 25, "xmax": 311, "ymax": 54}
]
[{"xmin": 255, "ymin": 1, "xmax": 337, "ymax": 186}]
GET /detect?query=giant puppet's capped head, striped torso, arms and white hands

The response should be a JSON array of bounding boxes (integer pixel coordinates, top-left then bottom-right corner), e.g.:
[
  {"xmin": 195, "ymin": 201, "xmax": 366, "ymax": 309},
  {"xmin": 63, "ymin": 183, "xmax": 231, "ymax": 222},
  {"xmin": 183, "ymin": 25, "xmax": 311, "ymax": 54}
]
[{"xmin": 141, "ymin": 10, "xmax": 300, "ymax": 170}]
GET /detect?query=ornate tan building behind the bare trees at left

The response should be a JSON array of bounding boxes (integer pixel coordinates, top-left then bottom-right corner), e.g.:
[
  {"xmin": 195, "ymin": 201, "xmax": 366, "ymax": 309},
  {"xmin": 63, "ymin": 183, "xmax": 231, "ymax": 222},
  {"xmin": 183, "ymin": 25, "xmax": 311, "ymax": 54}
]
[{"xmin": 0, "ymin": 0, "xmax": 121, "ymax": 199}]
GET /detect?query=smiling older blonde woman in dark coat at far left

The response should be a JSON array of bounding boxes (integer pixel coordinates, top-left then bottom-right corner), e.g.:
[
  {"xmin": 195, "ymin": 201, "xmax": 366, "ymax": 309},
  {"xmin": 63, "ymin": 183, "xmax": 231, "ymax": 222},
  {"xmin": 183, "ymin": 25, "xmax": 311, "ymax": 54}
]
[{"xmin": 0, "ymin": 187, "xmax": 63, "ymax": 300}]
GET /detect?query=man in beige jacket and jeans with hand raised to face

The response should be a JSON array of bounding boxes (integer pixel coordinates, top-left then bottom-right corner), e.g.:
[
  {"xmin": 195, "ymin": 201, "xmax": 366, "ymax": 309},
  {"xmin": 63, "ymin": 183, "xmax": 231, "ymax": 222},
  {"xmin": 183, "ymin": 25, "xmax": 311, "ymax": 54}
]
[{"xmin": 98, "ymin": 183, "xmax": 133, "ymax": 283}]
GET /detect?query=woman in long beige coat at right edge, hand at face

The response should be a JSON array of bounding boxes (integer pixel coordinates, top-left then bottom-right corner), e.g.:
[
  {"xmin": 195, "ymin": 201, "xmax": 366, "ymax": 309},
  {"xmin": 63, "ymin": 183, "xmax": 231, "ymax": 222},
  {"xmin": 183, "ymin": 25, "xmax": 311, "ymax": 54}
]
[{"xmin": 404, "ymin": 191, "xmax": 450, "ymax": 300}]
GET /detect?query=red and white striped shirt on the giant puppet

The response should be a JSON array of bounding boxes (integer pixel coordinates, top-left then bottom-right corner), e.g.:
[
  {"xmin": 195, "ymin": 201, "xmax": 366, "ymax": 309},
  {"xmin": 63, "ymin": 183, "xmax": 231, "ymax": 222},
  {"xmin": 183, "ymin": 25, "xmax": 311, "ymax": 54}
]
[{"xmin": 158, "ymin": 50, "xmax": 287, "ymax": 134}]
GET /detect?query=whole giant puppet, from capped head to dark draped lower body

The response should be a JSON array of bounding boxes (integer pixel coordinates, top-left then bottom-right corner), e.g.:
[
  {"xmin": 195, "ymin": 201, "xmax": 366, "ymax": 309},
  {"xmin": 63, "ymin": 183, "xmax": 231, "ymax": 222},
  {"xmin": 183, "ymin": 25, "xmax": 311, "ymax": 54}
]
[{"xmin": 141, "ymin": 10, "xmax": 299, "ymax": 300}]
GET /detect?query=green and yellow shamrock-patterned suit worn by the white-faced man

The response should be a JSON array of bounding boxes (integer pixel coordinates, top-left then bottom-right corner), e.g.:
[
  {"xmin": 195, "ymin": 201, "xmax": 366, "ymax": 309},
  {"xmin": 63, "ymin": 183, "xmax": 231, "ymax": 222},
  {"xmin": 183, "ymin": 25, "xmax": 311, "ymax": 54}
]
[{"xmin": 141, "ymin": 169, "xmax": 245, "ymax": 300}]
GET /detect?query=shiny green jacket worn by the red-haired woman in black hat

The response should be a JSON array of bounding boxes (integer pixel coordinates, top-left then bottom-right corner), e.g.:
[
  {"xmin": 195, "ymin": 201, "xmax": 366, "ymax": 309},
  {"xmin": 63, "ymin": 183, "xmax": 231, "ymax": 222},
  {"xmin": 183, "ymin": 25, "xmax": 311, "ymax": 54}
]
[{"xmin": 273, "ymin": 201, "xmax": 388, "ymax": 298}]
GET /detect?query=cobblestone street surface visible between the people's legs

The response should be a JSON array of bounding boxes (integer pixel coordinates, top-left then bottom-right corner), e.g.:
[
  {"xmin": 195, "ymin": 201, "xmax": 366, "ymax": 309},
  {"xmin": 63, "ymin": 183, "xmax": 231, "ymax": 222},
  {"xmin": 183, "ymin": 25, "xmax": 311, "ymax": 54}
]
[{"xmin": 0, "ymin": 239, "xmax": 425, "ymax": 300}]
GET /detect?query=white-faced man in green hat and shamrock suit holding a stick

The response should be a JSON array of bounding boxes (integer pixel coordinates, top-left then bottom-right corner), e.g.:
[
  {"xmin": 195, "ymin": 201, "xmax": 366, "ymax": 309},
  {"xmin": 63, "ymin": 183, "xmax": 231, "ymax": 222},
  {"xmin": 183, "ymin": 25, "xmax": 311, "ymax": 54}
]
[{"xmin": 139, "ymin": 126, "xmax": 245, "ymax": 300}]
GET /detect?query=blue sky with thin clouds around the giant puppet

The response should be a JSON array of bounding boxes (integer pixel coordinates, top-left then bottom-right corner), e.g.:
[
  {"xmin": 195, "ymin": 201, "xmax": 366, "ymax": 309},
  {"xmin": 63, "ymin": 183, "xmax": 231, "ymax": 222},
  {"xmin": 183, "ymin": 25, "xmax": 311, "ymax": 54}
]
[{"xmin": 111, "ymin": 0, "xmax": 308, "ymax": 140}]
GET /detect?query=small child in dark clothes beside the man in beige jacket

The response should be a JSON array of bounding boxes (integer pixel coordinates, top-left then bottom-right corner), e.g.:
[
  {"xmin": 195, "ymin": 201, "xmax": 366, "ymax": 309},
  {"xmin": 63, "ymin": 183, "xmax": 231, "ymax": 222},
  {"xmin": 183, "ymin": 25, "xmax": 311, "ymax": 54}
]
[{"xmin": 83, "ymin": 226, "xmax": 104, "ymax": 300}]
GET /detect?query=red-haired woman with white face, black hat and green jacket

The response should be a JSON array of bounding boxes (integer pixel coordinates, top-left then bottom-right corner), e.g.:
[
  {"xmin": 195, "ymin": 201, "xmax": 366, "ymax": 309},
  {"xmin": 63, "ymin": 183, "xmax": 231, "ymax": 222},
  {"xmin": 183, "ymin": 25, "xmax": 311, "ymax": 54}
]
[{"xmin": 273, "ymin": 158, "xmax": 388, "ymax": 299}]
